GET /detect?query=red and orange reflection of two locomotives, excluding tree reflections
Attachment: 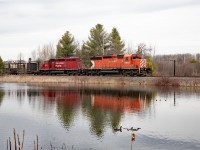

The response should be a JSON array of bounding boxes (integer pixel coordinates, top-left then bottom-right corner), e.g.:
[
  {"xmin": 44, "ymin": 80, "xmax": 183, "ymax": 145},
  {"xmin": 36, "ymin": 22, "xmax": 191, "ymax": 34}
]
[{"xmin": 39, "ymin": 88, "xmax": 153, "ymax": 112}]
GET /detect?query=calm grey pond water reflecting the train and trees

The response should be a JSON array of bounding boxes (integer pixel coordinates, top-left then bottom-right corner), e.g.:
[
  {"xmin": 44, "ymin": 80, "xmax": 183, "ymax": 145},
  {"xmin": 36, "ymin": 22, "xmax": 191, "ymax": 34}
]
[{"xmin": 0, "ymin": 83, "xmax": 200, "ymax": 150}]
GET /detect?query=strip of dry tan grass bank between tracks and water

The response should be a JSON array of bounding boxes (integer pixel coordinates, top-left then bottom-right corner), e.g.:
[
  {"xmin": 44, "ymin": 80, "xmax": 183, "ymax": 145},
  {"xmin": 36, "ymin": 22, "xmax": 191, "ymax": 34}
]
[{"xmin": 0, "ymin": 75, "xmax": 200, "ymax": 87}]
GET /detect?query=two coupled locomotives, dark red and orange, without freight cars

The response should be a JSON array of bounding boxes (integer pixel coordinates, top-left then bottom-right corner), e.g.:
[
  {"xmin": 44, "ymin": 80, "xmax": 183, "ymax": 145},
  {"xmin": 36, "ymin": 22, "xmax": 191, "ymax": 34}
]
[{"xmin": 39, "ymin": 54, "xmax": 151, "ymax": 76}]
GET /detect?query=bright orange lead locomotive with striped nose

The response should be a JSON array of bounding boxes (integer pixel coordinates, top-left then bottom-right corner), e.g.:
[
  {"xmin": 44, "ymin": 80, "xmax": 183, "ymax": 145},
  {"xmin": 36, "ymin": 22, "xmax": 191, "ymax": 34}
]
[{"xmin": 90, "ymin": 54, "xmax": 151, "ymax": 76}]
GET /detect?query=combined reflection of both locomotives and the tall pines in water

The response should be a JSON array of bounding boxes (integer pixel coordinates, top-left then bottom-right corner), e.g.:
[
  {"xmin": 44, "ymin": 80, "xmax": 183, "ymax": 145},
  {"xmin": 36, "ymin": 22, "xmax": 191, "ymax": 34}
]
[{"xmin": 28, "ymin": 87, "xmax": 153, "ymax": 137}]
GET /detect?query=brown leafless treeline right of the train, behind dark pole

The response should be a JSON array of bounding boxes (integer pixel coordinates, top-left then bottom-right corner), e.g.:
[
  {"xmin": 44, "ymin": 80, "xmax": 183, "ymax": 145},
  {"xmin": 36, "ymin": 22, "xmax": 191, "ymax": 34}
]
[{"xmin": 153, "ymin": 54, "xmax": 200, "ymax": 76}]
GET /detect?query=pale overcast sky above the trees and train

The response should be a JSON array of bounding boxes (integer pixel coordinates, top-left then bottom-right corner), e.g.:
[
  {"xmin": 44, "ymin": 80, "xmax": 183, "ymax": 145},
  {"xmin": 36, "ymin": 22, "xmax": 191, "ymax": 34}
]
[{"xmin": 0, "ymin": 0, "xmax": 200, "ymax": 60}]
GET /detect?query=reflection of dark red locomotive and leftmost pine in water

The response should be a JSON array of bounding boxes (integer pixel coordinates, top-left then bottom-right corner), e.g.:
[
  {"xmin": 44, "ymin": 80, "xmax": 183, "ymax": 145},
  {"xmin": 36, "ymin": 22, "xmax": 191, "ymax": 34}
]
[{"xmin": 42, "ymin": 87, "xmax": 81, "ymax": 129}]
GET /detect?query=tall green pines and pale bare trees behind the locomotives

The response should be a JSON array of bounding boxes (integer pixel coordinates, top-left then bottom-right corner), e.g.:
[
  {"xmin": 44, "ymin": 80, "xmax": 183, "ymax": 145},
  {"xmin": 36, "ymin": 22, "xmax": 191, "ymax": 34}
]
[{"xmin": 32, "ymin": 24, "xmax": 125, "ymax": 64}]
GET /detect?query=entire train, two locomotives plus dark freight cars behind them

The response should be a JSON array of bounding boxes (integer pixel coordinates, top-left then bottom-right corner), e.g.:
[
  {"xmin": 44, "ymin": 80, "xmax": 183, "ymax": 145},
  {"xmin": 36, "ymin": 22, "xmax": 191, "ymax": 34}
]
[{"xmin": 5, "ymin": 54, "xmax": 151, "ymax": 76}]
